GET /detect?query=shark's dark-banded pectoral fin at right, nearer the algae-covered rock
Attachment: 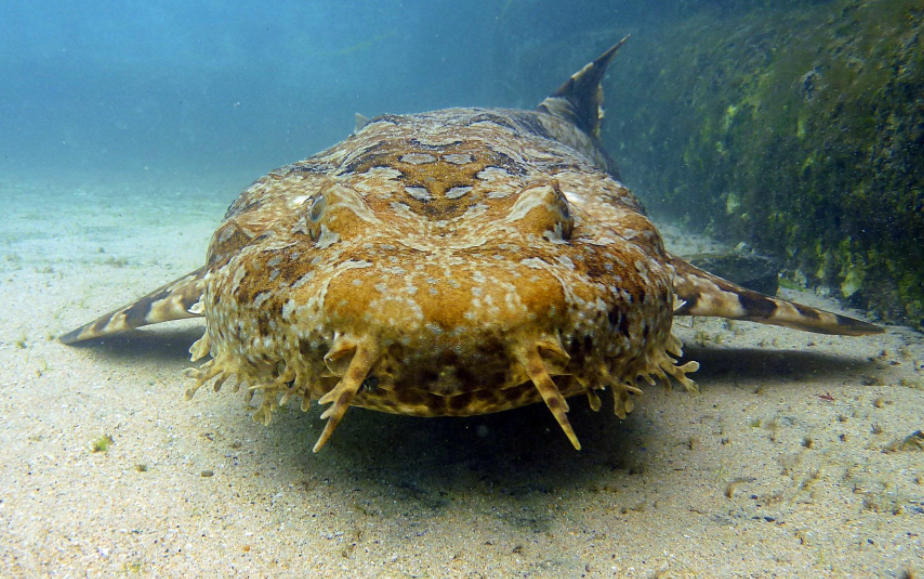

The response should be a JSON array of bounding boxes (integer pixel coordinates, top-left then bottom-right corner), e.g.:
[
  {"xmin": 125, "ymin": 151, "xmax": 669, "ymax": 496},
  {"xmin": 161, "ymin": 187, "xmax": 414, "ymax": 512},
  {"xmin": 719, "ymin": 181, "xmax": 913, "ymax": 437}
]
[{"xmin": 670, "ymin": 256, "xmax": 885, "ymax": 336}]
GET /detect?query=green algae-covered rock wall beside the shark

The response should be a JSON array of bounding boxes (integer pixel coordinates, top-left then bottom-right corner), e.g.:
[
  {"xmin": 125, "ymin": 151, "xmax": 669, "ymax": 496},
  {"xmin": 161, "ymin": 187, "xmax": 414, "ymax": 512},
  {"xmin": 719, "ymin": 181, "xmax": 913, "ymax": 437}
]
[{"xmin": 603, "ymin": 0, "xmax": 924, "ymax": 327}]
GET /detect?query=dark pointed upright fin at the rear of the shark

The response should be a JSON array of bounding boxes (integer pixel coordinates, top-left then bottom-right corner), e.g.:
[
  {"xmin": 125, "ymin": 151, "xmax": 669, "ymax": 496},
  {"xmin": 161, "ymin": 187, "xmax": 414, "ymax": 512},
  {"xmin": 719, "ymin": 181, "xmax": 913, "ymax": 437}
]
[{"xmin": 538, "ymin": 36, "xmax": 629, "ymax": 138}]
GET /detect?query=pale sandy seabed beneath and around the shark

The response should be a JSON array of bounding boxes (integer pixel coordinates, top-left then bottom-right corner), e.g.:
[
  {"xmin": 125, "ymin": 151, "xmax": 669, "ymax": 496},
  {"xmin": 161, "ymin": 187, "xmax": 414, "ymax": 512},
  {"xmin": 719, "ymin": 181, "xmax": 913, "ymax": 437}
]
[{"xmin": 0, "ymin": 181, "xmax": 924, "ymax": 578}]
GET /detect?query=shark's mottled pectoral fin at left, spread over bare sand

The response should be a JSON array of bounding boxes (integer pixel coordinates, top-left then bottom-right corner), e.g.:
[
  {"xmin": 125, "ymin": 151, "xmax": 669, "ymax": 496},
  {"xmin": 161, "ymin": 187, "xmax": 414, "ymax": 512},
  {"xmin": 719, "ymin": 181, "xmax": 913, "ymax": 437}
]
[{"xmin": 58, "ymin": 267, "xmax": 206, "ymax": 344}]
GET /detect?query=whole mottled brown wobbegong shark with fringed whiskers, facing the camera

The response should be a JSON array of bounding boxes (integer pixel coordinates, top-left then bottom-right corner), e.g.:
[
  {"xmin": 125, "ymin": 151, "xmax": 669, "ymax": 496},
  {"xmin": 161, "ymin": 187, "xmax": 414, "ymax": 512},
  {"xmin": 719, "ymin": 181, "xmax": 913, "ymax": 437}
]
[{"xmin": 60, "ymin": 39, "xmax": 882, "ymax": 452}]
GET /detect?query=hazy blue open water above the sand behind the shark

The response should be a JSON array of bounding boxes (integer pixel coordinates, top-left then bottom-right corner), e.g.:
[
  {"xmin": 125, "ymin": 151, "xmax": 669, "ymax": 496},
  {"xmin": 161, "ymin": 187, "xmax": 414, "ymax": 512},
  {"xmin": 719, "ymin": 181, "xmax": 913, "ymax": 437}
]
[{"xmin": 0, "ymin": 0, "xmax": 660, "ymax": 188}]
